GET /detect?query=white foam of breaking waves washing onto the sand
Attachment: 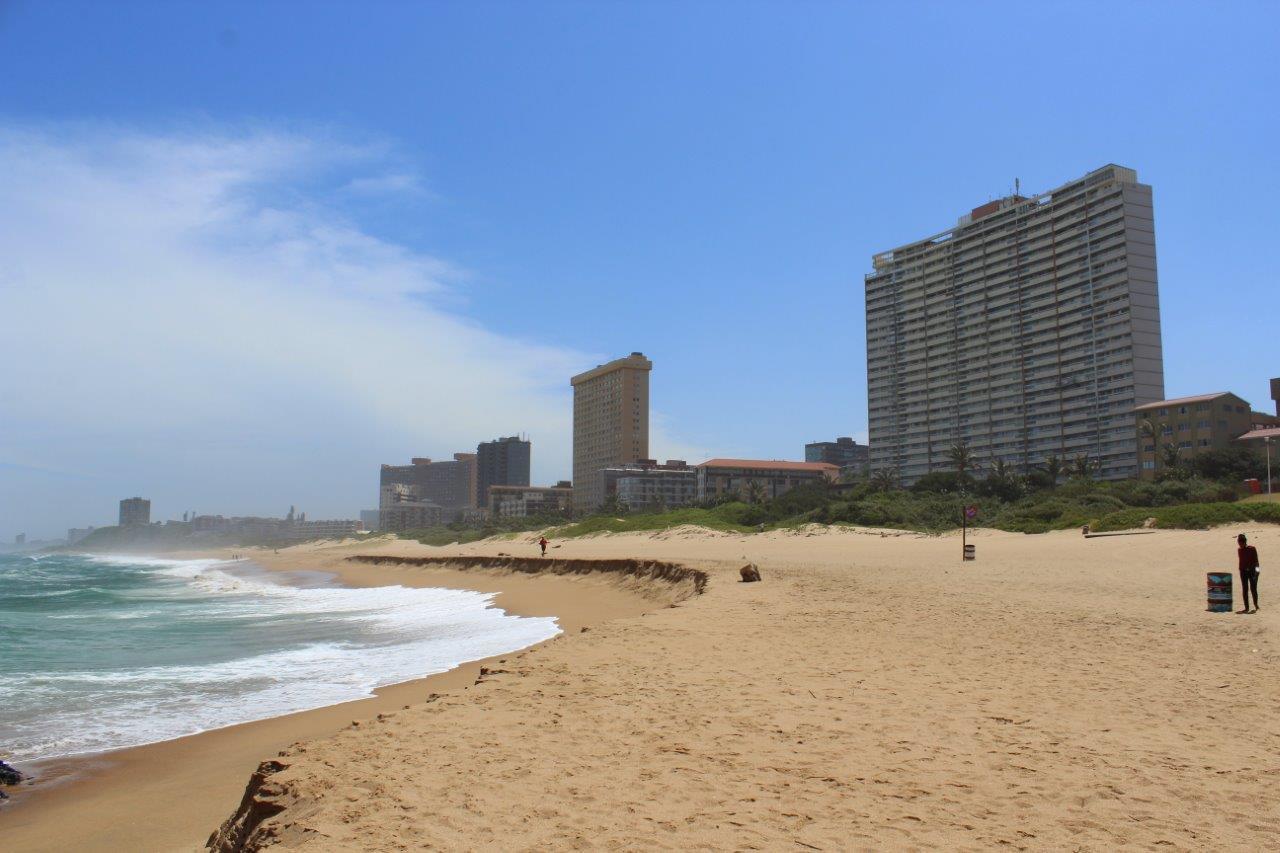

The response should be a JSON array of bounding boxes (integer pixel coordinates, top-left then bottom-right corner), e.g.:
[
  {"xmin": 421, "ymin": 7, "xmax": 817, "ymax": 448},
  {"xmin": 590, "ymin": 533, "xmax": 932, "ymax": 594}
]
[{"xmin": 0, "ymin": 557, "xmax": 559, "ymax": 760}]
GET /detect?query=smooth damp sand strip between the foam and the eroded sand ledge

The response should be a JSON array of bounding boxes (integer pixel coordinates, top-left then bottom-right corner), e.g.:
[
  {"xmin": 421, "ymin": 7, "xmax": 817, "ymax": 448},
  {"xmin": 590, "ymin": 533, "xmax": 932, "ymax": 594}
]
[{"xmin": 0, "ymin": 539, "xmax": 680, "ymax": 850}]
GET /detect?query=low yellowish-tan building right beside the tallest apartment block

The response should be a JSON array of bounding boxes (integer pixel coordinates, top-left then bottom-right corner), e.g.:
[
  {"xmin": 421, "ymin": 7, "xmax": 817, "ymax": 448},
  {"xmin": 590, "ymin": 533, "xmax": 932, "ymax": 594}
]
[{"xmin": 1133, "ymin": 391, "xmax": 1280, "ymax": 479}]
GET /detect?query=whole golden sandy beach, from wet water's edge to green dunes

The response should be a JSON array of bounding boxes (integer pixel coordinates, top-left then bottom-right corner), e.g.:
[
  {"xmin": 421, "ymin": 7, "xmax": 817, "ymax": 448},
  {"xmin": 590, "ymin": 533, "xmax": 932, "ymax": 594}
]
[{"xmin": 0, "ymin": 528, "xmax": 1280, "ymax": 850}]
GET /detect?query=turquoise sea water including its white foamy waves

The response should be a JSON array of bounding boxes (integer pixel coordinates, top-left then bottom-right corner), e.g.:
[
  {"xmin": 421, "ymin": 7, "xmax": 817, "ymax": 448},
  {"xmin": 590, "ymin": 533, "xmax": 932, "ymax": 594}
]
[{"xmin": 0, "ymin": 555, "xmax": 559, "ymax": 762}]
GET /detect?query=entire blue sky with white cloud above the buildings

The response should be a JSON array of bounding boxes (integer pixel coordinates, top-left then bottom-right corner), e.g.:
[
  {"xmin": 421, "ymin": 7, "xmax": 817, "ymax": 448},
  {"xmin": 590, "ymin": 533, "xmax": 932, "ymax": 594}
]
[{"xmin": 0, "ymin": 0, "xmax": 1280, "ymax": 539}]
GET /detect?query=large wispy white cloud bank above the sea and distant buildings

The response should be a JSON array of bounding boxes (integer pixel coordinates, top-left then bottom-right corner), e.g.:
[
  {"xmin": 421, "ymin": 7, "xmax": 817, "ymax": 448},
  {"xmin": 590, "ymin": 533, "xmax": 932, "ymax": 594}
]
[{"xmin": 0, "ymin": 127, "xmax": 598, "ymax": 533}]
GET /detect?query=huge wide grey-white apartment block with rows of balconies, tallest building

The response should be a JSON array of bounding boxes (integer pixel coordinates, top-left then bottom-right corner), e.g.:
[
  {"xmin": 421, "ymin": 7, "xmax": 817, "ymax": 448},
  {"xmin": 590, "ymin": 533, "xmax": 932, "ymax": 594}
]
[{"xmin": 865, "ymin": 165, "xmax": 1165, "ymax": 483}]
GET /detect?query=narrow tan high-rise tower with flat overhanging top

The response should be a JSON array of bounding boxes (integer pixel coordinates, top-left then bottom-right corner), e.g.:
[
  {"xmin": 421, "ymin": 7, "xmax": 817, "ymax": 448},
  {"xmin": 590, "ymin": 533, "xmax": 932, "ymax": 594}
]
[{"xmin": 570, "ymin": 352, "xmax": 653, "ymax": 511}]
